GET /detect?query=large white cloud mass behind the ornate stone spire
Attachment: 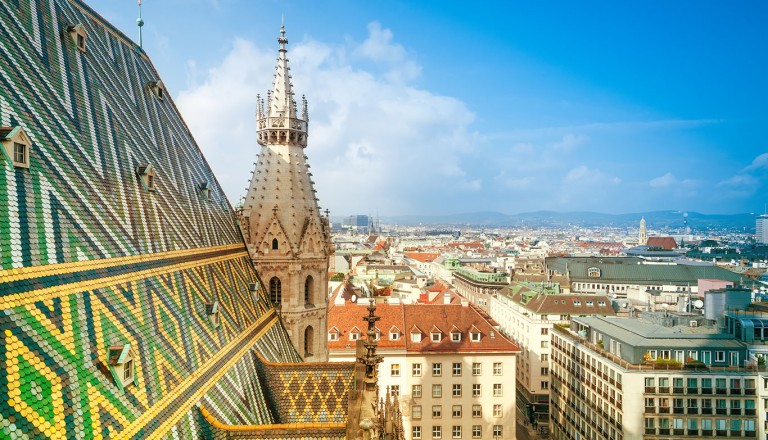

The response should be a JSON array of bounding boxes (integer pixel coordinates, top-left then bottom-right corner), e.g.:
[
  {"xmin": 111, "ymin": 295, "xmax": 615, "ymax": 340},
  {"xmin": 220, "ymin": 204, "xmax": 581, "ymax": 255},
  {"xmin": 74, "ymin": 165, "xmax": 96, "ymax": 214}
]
[{"xmin": 176, "ymin": 24, "xmax": 482, "ymax": 215}]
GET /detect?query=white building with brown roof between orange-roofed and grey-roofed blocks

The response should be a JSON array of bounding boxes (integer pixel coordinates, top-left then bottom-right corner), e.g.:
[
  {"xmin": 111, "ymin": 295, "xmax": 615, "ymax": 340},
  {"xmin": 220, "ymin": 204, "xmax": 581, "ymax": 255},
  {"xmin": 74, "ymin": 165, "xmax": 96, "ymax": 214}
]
[{"xmin": 490, "ymin": 282, "xmax": 615, "ymax": 423}]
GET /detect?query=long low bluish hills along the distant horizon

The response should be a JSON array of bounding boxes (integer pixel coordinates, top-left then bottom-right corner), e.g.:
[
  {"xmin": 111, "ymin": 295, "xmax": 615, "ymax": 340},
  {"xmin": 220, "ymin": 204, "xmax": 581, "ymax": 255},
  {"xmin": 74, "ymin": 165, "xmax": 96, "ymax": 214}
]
[{"xmin": 381, "ymin": 211, "xmax": 755, "ymax": 233}]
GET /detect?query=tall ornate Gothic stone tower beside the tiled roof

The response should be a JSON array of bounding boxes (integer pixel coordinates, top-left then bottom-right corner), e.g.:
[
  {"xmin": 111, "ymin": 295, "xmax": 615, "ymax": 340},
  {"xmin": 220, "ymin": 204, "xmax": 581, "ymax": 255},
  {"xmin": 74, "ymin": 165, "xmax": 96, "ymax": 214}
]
[{"xmin": 240, "ymin": 26, "xmax": 331, "ymax": 361}]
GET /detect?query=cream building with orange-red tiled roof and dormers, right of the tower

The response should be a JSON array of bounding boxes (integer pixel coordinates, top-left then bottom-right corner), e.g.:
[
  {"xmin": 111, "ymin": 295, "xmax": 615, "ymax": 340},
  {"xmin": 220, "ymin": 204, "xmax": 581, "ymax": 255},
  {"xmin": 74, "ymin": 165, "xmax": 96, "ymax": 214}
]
[{"xmin": 328, "ymin": 286, "xmax": 519, "ymax": 440}]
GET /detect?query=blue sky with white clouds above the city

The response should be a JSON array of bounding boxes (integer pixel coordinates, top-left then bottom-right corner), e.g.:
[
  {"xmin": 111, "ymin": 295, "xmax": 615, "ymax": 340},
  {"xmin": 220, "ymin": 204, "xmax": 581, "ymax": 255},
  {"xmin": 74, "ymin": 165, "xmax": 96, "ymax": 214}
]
[{"xmin": 86, "ymin": 0, "xmax": 768, "ymax": 216}]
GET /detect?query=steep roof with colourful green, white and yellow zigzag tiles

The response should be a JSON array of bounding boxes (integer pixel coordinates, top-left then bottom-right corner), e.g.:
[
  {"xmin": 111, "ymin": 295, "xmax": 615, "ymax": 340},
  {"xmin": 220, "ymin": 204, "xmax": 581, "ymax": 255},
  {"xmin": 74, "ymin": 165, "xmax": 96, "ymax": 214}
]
[{"xmin": 0, "ymin": 0, "xmax": 328, "ymax": 439}]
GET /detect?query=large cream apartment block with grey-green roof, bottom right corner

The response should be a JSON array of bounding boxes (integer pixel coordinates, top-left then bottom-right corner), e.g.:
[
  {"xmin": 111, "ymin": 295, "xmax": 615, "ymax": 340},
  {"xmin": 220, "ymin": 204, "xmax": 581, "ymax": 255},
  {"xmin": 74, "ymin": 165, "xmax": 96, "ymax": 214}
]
[{"xmin": 550, "ymin": 314, "xmax": 768, "ymax": 440}]
